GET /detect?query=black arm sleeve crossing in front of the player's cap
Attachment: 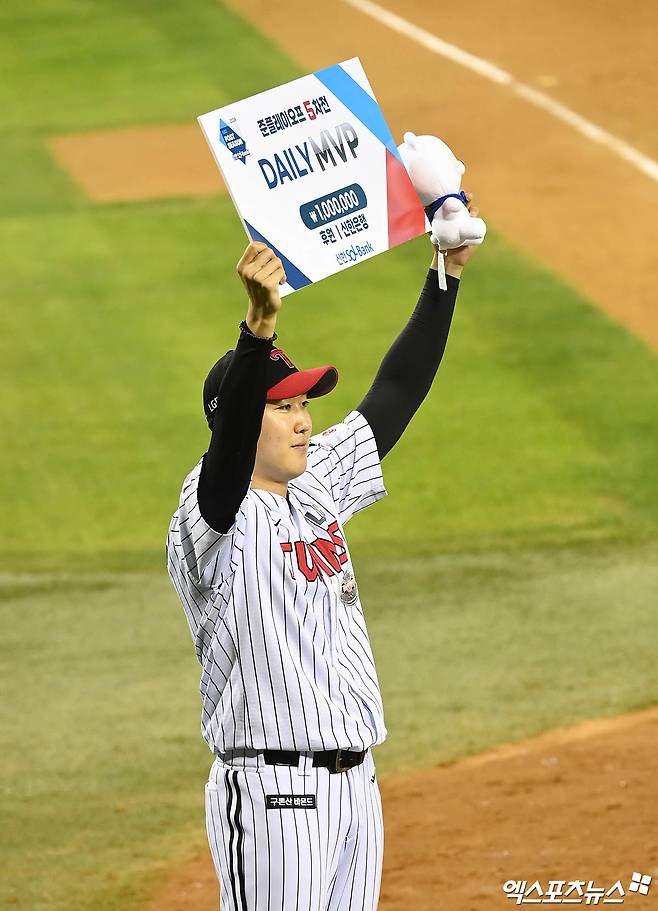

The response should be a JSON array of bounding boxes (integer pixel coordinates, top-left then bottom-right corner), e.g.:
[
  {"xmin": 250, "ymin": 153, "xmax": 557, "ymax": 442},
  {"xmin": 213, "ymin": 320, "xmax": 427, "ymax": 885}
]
[{"xmin": 197, "ymin": 332, "xmax": 272, "ymax": 534}]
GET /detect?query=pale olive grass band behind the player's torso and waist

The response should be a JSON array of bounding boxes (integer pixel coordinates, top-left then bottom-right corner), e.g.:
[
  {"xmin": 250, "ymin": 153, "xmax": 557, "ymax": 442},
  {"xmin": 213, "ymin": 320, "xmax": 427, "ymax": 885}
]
[{"xmin": 0, "ymin": 544, "xmax": 658, "ymax": 911}]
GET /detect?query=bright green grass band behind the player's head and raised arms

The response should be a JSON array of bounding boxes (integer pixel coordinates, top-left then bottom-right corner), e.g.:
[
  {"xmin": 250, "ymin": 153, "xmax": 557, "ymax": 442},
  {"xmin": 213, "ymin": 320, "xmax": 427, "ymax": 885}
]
[{"xmin": 0, "ymin": 200, "xmax": 658, "ymax": 570}]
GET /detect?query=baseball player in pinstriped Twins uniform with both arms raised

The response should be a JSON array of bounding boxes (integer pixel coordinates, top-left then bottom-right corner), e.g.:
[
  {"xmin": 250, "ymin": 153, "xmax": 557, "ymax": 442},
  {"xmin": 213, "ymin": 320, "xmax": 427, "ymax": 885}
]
[{"xmin": 167, "ymin": 201, "xmax": 477, "ymax": 911}]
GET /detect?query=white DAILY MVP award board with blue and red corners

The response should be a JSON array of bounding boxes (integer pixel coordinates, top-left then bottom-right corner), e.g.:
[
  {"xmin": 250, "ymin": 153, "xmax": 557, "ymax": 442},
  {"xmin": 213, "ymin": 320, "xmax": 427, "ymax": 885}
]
[{"xmin": 199, "ymin": 57, "xmax": 429, "ymax": 295}]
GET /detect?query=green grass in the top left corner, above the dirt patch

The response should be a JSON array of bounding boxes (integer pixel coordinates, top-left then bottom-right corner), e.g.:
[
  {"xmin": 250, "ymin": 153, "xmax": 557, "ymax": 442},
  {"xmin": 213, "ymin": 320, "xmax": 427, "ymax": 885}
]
[{"xmin": 0, "ymin": 0, "xmax": 301, "ymax": 217}]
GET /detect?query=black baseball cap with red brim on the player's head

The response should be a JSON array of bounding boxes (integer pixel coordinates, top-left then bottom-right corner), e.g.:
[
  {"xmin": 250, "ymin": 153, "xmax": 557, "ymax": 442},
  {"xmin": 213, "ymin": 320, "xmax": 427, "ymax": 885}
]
[{"xmin": 203, "ymin": 348, "xmax": 338, "ymax": 427}]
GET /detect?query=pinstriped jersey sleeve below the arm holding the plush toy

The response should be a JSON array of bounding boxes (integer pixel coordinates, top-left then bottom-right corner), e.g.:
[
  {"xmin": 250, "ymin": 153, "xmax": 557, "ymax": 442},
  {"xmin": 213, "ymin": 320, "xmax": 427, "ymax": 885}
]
[{"xmin": 307, "ymin": 411, "xmax": 386, "ymax": 525}]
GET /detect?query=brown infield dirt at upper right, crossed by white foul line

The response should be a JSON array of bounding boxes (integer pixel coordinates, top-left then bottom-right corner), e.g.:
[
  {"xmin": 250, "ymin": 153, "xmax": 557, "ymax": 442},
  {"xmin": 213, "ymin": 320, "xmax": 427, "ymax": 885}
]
[{"xmin": 224, "ymin": 0, "xmax": 658, "ymax": 350}]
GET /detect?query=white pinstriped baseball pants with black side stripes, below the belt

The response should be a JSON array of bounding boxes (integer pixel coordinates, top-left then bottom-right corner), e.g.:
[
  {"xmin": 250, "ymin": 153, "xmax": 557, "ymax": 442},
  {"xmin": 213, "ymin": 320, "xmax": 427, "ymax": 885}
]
[{"xmin": 206, "ymin": 751, "xmax": 384, "ymax": 911}]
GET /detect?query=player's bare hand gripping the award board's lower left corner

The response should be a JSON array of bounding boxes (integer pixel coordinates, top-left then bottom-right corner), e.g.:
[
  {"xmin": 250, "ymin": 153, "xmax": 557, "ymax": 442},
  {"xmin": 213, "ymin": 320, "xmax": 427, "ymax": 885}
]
[{"xmin": 237, "ymin": 240, "xmax": 286, "ymax": 336}]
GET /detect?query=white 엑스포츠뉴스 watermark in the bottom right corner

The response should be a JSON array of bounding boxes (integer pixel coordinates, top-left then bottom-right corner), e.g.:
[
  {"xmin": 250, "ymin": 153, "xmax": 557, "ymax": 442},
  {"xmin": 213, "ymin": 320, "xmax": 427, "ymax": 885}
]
[{"xmin": 503, "ymin": 873, "xmax": 651, "ymax": 905}]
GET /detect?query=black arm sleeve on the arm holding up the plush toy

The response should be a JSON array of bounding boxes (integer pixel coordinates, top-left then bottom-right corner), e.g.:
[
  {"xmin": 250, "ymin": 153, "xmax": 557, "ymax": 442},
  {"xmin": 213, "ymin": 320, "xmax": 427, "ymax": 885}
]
[{"xmin": 356, "ymin": 269, "xmax": 459, "ymax": 459}]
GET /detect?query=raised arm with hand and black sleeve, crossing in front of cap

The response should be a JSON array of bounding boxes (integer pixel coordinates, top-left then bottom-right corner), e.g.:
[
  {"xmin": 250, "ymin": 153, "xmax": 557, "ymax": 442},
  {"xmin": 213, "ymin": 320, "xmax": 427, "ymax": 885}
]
[{"xmin": 198, "ymin": 241, "xmax": 285, "ymax": 534}]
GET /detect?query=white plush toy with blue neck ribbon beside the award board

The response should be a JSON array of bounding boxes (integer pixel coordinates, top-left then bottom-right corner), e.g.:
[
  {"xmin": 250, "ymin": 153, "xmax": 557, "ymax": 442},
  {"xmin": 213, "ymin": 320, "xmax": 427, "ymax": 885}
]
[{"xmin": 398, "ymin": 133, "xmax": 487, "ymax": 288}]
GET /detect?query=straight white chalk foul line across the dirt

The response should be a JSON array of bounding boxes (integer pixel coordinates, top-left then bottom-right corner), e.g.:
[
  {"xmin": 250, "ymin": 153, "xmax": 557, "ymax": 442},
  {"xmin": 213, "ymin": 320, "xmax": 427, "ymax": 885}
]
[{"xmin": 344, "ymin": 0, "xmax": 658, "ymax": 182}]
